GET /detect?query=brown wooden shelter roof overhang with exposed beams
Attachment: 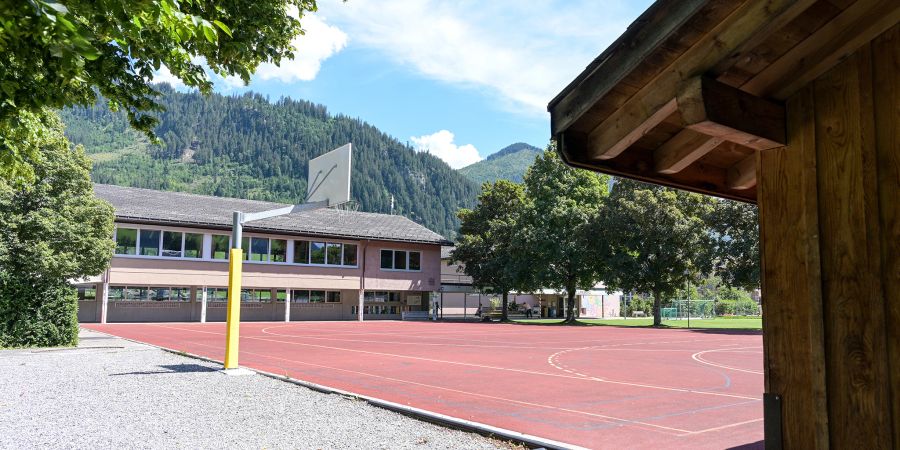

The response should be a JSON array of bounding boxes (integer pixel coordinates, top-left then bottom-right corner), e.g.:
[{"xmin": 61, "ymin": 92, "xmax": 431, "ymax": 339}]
[{"xmin": 548, "ymin": 0, "xmax": 900, "ymax": 202}]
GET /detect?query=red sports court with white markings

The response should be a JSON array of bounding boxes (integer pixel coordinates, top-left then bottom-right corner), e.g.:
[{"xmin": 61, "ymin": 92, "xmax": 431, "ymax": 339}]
[{"xmin": 83, "ymin": 321, "xmax": 763, "ymax": 448}]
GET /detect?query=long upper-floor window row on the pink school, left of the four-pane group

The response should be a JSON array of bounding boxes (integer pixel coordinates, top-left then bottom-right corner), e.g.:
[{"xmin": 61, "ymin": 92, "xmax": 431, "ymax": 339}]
[{"xmin": 115, "ymin": 227, "xmax": 360, "ymax": 270}]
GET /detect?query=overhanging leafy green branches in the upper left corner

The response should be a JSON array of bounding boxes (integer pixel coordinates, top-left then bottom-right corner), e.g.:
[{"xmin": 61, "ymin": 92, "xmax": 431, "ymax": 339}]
[{"xmin": 0, "ymin": 0, "xmax": 316, "ymax": 177}]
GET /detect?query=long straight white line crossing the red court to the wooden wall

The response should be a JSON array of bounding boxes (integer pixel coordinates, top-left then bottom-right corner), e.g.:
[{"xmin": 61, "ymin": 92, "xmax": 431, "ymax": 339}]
[{"xmin": 151, "ymin": 324, "xmax": 760, "ymax": 401}]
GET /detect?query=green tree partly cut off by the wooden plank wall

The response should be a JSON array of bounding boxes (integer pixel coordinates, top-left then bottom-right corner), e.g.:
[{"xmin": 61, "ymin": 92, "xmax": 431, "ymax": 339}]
[{"xmin": 706, "ymin": 200, "xmax": 760, "ymax": 290}]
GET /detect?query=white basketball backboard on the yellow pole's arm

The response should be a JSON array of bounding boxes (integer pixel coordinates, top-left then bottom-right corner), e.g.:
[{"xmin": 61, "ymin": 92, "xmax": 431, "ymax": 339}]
[{"xmin": 306, "ymin": 144, "xmax": 351, "ymax": 206}]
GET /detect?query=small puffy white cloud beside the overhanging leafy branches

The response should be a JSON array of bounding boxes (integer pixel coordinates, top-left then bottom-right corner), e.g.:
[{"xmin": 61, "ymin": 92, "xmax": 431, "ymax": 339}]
[{"xmin": 255, "ymin": 15, "xmax": 347, "ymax": 83}]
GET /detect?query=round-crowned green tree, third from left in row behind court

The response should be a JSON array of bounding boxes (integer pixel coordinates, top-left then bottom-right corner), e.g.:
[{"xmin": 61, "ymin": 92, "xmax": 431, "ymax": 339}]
[{"xmin": 595, "ymin": 179, "xmax": 710, "ymax": 326}]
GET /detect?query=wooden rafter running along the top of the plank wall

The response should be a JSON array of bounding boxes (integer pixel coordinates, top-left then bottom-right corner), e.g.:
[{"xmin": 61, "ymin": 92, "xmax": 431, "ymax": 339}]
[{"xmin": 741, "ymin": 0, "xmax": 900, "ymax": 99}]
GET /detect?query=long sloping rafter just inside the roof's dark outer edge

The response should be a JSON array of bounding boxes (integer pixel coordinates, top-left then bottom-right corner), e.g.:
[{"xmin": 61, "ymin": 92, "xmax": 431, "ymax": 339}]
[{"xmin": 584, "ymin": 0, "xmax": 808, "ymax": 160}]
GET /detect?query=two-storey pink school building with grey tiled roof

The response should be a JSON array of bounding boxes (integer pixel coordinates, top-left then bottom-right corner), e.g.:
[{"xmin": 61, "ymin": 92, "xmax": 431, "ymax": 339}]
[{"xmin": 78, "ymin": 184, "xmax": 449, "ymax": 323}]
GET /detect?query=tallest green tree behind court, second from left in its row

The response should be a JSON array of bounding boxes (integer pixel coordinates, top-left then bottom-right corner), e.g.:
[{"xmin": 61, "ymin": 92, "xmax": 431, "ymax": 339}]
[{"xmin": 522, "ymin": 149, "xmax": 608, "ymax": 323}]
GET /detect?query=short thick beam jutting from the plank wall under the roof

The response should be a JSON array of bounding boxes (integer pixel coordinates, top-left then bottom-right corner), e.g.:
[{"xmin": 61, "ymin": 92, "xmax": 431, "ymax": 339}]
[{"xmin": 677, "ymin": 77, "xmax": 786, "ymax": 150}]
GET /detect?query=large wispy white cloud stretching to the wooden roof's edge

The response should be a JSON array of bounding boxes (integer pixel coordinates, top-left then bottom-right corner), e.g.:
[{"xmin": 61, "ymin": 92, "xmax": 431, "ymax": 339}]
[{"xmin": 319, "ymin": 0, "xmax": 644, "ymax": 115}]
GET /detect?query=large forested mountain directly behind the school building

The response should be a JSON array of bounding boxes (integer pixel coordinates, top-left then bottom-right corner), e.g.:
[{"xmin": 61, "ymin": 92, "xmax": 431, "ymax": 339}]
[{"xmin": 61, "ymin": 85, "xmax": 479, "ymax": 239}]
